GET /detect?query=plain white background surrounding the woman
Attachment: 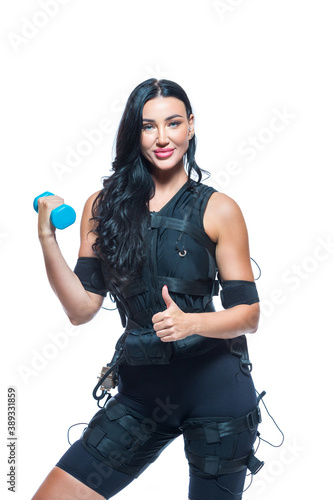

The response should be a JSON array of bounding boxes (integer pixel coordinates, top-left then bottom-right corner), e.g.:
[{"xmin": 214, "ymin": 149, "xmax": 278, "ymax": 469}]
[{"xmin": 0, "ymin": 0, "xmax": 333, "ymax": 500}]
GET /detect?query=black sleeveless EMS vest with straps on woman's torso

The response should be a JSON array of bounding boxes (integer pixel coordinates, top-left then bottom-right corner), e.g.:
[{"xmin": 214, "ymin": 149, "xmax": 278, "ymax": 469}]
[{"xmin": 104, "ymin": 180, "xmax": 249, "ymax": 365}]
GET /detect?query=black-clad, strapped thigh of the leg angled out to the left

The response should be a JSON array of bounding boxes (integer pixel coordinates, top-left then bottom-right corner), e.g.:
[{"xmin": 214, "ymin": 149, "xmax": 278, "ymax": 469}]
[{"xmin": 57, "ymin": 398, "xmax": 181, "ymax": 498}]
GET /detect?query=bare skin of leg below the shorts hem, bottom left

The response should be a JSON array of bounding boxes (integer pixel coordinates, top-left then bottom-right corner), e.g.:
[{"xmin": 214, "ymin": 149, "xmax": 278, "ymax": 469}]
[{"xmin": 32, "ymin": 467, "xmax": 105, "ymax": 500}]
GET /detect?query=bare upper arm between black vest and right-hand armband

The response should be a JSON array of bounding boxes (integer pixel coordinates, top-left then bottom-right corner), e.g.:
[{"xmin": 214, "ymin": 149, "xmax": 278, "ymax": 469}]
[{"xmin": 204, "ymin": 193, "xmax": 254, "ymax": 281}]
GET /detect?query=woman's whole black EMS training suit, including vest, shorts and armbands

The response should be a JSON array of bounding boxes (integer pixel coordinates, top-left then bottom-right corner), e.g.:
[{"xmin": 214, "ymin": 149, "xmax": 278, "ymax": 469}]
[{"xmin": 57, "ymin": 180, "xmax": 262, "ymax": 500}]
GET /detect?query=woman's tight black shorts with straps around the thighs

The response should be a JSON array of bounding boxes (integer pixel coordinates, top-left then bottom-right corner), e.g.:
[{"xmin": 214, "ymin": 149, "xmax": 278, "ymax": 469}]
[{"xmin": 56, "ymin": 343, "xmax": 257, "ymax": 500}]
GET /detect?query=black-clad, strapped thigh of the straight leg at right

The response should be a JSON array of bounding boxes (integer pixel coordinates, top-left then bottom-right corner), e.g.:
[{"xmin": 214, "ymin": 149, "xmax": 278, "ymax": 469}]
[{"xmin": 181, "ymin": 418, "xmax": 260, "ymax": 500}]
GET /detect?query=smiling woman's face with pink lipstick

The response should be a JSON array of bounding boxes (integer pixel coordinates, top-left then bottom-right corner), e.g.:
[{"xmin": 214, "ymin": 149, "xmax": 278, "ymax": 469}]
[{"xmin": 141, "ymin": 97, "xmax": 194, "ymax": 175}]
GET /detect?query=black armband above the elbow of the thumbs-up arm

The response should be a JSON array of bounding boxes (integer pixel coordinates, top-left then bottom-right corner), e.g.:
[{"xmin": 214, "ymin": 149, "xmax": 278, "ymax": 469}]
[{"xmin": 220, "ymin": 280, "xmax": 259, "ymax": 309}]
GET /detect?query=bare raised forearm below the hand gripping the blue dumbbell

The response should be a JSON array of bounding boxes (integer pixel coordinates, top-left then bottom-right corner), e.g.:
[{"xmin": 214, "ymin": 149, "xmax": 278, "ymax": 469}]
[{"xmin": 39, "ymin": 235, "xmax": 97, "ymax": 325}]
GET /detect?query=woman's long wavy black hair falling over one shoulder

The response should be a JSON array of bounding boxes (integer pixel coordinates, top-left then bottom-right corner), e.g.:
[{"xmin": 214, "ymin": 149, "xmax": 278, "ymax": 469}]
[{"xmin": 92, "ymin": 78, "xmax": 206, "ymax": 284}]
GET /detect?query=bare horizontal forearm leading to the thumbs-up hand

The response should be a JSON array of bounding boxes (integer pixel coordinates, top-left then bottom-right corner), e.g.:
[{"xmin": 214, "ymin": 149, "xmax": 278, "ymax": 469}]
[{"xmin": 188, "ymin": 303, "xmax": 259, "ymax": 339}]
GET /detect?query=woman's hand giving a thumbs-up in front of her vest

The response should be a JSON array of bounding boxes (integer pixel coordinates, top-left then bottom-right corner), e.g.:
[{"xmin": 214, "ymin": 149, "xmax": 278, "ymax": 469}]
[{"xmin": 152, "ymin": 285, "xmax": 191, "ymax": 342}]
